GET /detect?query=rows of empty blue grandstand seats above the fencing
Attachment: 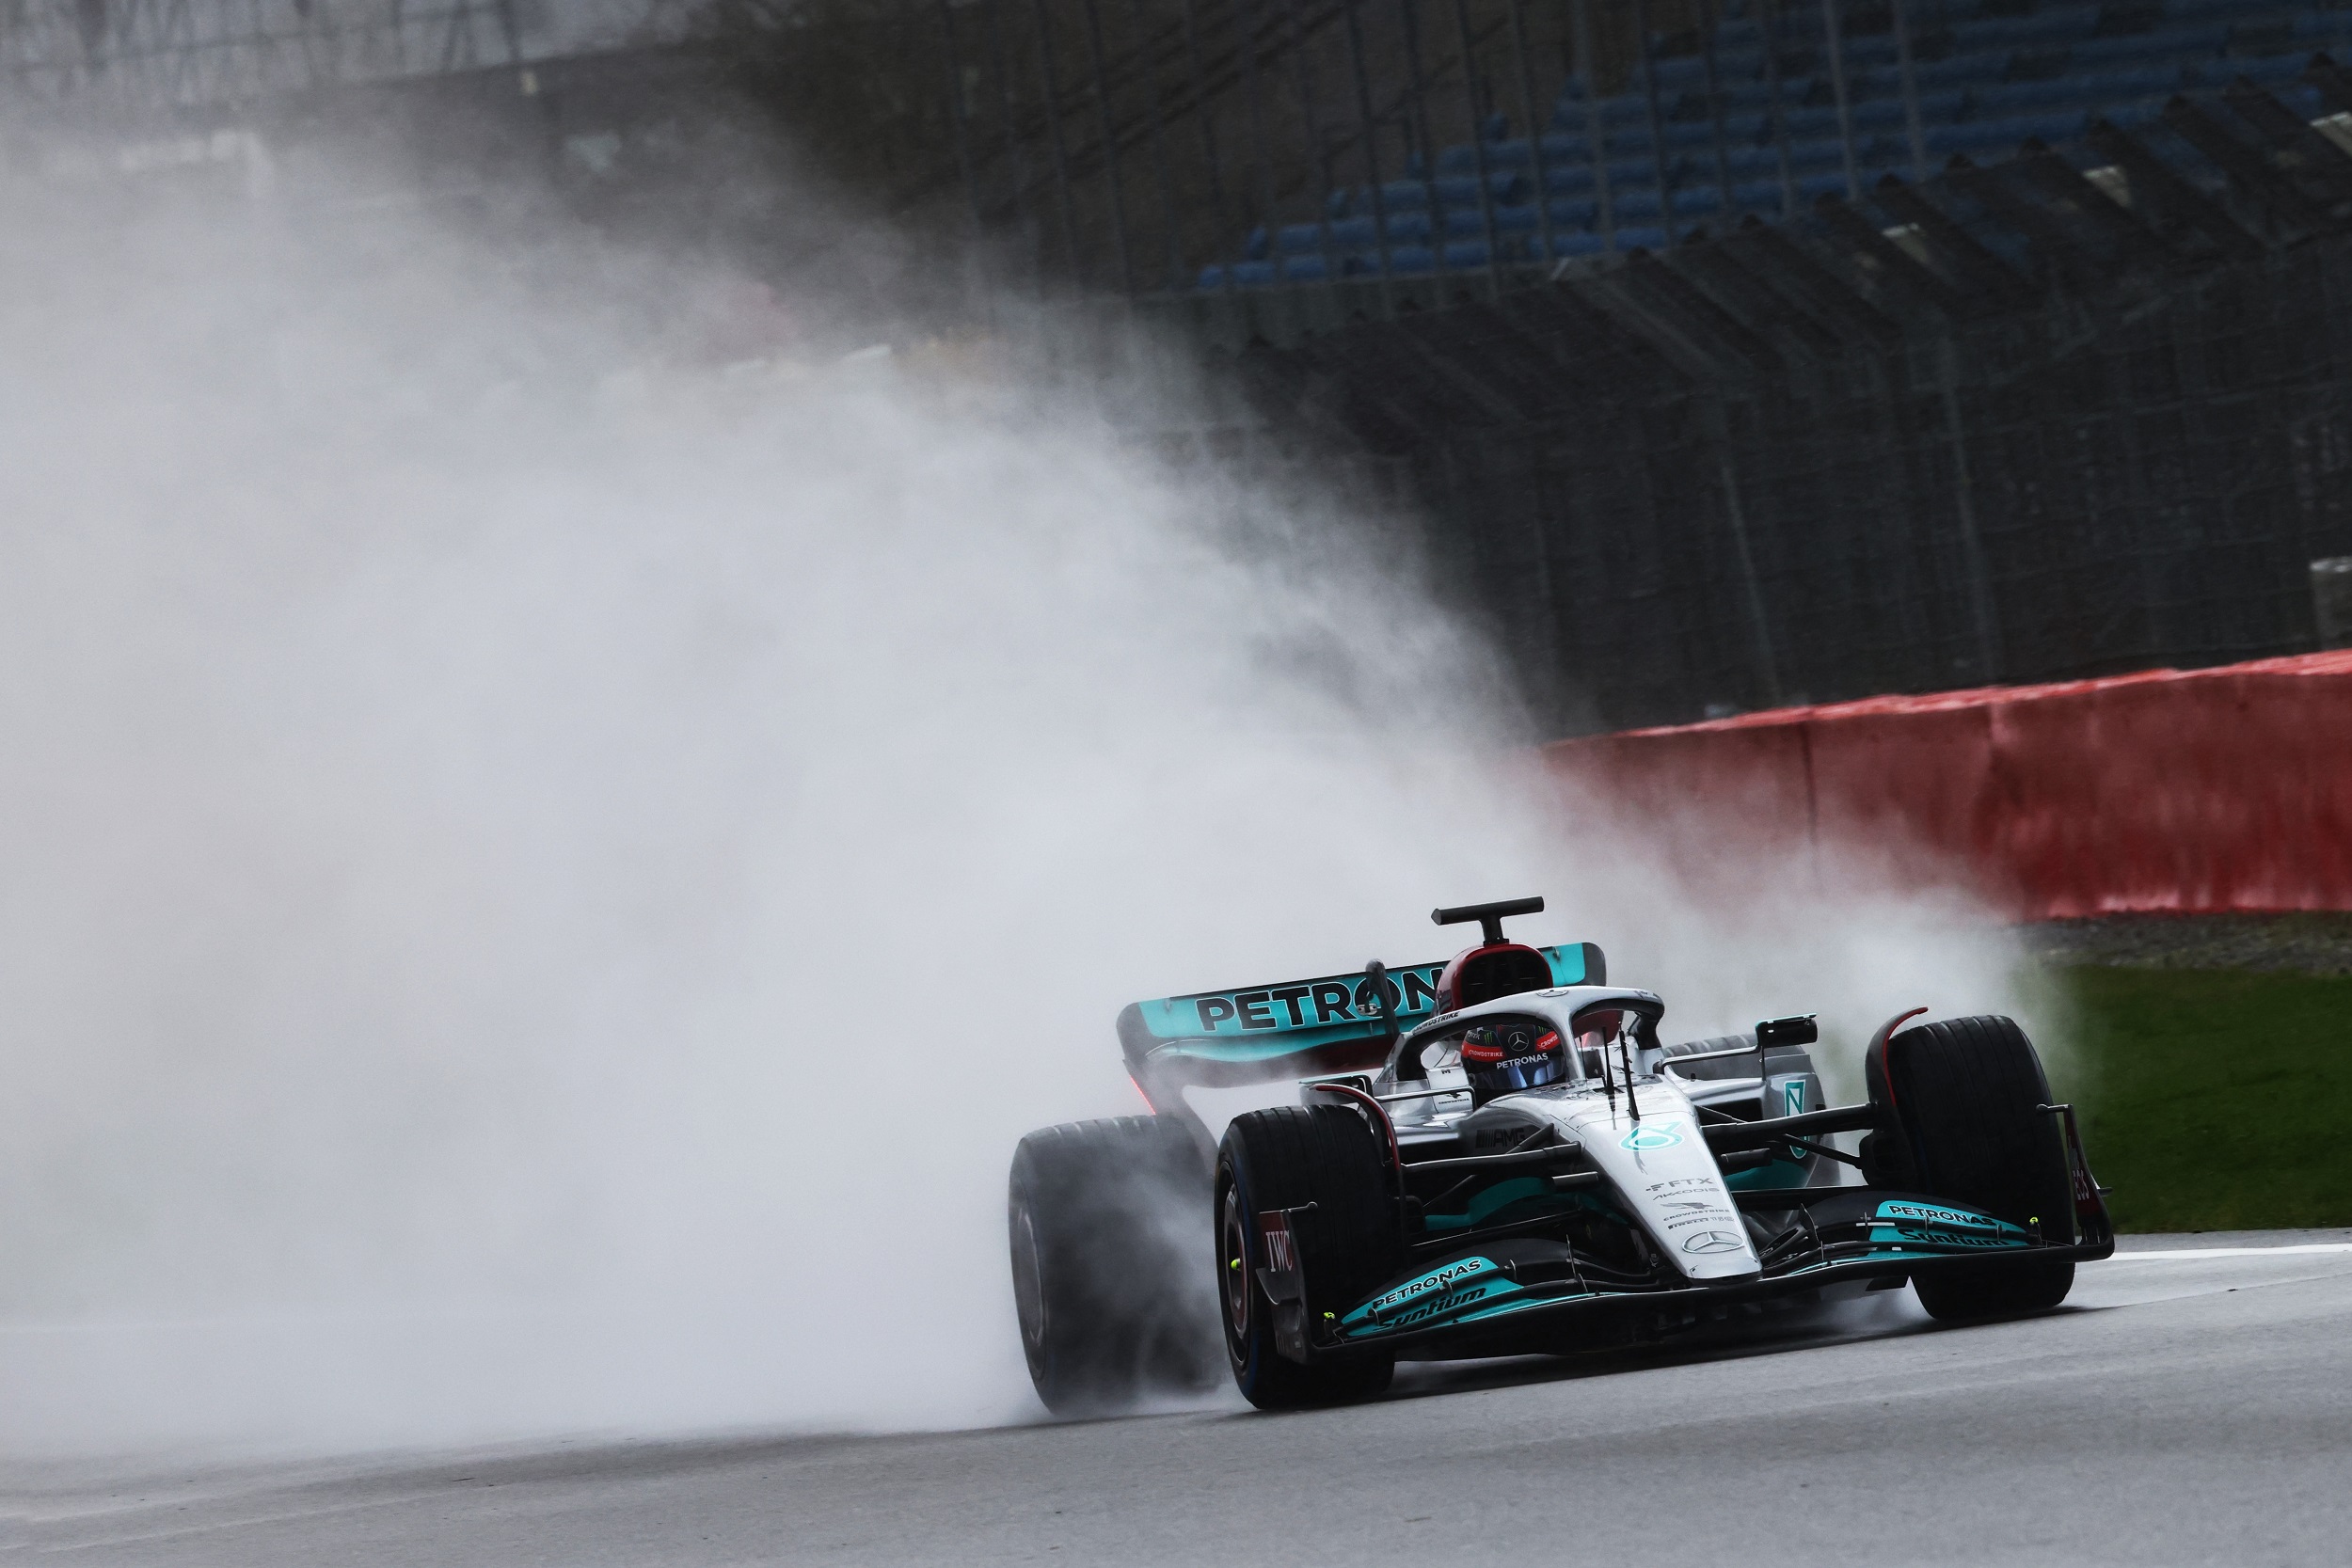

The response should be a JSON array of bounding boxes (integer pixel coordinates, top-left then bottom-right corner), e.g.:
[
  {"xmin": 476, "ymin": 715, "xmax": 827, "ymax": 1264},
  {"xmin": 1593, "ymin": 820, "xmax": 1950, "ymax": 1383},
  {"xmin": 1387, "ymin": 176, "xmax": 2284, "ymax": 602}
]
[{"xmin": 1195, "ymin": 0, "xmax": 2352, "ymax": 292}]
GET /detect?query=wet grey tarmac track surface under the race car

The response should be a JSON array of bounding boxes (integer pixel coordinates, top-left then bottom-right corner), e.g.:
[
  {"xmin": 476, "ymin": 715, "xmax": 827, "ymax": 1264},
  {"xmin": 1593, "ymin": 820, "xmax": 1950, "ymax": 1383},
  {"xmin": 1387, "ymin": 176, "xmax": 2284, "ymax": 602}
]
[{"xmin": 0, "ymin": 1232, "xmax": 2352, "ymax": 1568}]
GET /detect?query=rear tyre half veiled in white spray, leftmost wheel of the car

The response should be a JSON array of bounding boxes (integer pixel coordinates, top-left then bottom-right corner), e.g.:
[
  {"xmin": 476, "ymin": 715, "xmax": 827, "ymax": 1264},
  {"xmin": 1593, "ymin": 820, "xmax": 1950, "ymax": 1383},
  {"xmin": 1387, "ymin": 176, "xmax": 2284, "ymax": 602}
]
[{"xmin": 1005, "ymin": 1117, "xmax": 1218, "ymax": 1416}]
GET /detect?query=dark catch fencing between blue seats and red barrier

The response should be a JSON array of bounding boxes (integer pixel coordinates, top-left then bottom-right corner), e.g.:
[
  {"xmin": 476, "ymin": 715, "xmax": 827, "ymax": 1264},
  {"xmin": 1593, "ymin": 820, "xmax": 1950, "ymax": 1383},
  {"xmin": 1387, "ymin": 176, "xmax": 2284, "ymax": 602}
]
[{"xmin": 1162, "ymin": 58, "xmax": 2352, "ymax": 736}]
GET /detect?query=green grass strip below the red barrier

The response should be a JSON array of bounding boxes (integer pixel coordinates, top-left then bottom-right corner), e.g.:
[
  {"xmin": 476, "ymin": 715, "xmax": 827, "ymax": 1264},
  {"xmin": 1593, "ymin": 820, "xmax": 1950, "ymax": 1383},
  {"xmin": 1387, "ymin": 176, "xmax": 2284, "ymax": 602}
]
[{"xmin": 2051, "ymin": 969, "xmax": 2352, "ymax": 1232}]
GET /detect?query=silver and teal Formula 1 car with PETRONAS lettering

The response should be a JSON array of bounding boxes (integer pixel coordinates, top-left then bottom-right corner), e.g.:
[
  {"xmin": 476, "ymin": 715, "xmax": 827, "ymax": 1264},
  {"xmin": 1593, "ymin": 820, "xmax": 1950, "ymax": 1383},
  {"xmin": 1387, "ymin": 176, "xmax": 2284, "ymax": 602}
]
[{"xmin": 1009, "ymin": 898, "xmax": 2115, "ymax": 1413}]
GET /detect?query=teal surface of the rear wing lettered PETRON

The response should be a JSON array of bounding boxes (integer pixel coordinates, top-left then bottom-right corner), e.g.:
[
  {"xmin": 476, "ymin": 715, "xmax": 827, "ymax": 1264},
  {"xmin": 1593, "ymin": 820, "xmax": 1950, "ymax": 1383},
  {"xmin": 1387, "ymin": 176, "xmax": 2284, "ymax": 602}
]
[{"xmin": 1136, "ymin": 942, "xmax": 1585, "ymax": 1063}]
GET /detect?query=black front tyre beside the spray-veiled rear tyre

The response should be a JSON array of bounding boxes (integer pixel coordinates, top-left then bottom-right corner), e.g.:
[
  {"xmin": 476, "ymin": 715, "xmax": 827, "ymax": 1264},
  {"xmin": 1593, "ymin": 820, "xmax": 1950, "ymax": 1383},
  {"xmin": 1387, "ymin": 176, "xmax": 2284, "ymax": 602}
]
[{"xmin": 1216, "ymin": 1105, "xmax": 1405, "ymax": 1411}]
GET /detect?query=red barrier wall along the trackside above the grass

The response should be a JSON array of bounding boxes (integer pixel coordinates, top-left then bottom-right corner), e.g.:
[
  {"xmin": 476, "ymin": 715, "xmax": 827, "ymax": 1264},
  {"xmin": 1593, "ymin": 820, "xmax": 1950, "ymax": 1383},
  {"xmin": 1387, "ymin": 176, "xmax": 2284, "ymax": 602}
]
[{"xmin": 1546, "ymin": 651, "xmax": 2352, "ymax": 919}]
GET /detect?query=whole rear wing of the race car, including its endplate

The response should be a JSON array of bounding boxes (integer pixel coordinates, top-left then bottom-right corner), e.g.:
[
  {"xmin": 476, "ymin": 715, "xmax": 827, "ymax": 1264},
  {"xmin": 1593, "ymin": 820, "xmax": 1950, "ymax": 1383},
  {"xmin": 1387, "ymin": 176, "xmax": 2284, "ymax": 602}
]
[{"xmin": 1120, "ymin": 942, "xmax": 1609, "ymax": 1102}]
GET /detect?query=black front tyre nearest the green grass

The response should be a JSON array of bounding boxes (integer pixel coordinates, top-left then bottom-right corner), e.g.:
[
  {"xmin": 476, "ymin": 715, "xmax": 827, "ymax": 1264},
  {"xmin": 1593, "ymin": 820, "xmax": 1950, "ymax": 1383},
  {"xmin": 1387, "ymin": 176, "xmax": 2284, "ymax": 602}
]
[{"xmin": 1866, "ymin": 1018, "xmax": 2074, "ymax": 1322}]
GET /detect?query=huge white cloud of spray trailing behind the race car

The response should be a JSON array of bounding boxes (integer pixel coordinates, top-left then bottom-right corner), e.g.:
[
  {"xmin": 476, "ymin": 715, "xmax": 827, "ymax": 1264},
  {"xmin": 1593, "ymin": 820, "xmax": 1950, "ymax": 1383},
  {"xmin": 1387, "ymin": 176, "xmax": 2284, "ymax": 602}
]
[{"xmin": 0, "ymin": 152, "xmax": 2011, "ymax": 1449}]
